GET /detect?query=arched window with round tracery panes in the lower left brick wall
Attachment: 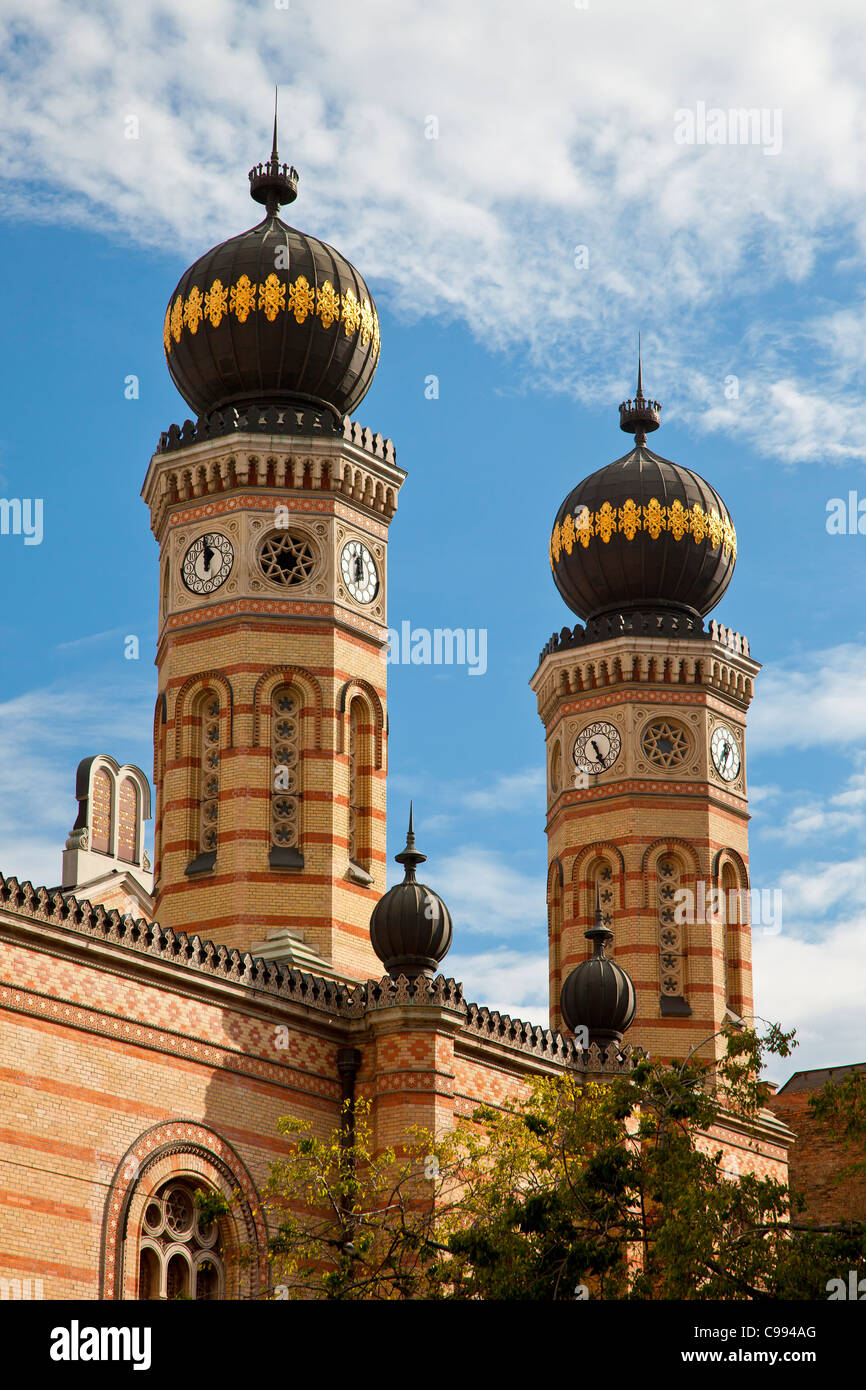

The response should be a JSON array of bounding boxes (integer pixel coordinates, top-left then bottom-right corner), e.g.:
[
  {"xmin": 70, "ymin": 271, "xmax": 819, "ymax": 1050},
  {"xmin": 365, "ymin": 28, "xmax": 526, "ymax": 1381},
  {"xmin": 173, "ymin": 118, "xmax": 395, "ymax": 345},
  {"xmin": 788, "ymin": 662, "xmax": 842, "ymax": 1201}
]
[{"xmin": 138, "ymin": 1179, "xmax": 225, "ymax": 1301}]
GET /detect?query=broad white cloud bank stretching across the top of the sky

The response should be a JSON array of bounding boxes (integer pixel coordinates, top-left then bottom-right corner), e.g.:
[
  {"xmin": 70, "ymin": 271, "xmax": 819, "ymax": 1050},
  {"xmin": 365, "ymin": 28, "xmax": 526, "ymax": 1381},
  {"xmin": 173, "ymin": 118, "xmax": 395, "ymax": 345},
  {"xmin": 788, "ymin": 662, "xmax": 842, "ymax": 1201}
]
[{"xmin": 0, "ymin": 0, "xmax": 866, "ymax": 463}]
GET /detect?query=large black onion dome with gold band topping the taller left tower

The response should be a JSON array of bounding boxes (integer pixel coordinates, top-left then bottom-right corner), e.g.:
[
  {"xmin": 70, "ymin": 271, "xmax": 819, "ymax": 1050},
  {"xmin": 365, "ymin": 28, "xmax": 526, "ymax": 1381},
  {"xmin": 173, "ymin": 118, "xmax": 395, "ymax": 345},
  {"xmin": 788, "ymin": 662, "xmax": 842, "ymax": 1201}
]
[{"xmin": 163, "ymin": 109, "xmax": 379, "ymax": 418}]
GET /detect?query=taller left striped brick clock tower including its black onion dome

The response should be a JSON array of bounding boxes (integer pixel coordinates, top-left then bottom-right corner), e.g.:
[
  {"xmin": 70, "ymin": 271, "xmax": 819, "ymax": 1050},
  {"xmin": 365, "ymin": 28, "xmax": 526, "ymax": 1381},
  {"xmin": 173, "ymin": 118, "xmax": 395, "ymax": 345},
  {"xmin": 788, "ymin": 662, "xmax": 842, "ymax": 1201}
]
[{"xmin": 143, "ymin": 129, "xmax": 405, "ymax": 979}]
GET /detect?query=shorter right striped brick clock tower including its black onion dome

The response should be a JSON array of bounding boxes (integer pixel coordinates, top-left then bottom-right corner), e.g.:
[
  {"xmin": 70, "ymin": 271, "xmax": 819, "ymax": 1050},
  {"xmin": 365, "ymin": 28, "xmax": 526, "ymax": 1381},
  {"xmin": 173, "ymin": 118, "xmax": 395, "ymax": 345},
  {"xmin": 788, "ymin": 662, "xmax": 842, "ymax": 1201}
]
[{"xmin": 531, "ymin": 366, "xmax": 759, "ymax": 1061}]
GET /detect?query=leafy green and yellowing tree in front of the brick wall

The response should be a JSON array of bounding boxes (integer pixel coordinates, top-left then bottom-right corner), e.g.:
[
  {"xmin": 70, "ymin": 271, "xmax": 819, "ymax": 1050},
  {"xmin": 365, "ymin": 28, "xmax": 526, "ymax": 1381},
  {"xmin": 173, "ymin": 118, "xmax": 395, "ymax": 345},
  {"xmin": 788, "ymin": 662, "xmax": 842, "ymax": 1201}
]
[{"xmin": 261, "ymin": 1027, "xmax": 866, "ymax": 1300}]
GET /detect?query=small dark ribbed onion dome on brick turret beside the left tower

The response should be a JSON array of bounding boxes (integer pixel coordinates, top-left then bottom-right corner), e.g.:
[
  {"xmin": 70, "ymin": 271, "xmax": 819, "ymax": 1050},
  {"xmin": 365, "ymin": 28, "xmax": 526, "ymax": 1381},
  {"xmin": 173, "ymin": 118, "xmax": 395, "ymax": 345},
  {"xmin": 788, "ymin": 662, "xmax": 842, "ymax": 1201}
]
[{"xmin": 370, "ymin": 806, "xmax": 452, "ymax": 980}]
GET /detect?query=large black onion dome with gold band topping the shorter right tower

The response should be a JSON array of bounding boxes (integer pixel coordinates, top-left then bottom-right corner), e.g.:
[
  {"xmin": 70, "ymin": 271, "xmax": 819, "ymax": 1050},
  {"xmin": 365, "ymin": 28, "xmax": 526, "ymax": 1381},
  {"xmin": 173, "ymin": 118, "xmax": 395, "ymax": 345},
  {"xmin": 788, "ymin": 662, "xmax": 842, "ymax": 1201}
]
[{"xmin": 550, "ymin": 359, "xmax": 737, "ymax": 620}]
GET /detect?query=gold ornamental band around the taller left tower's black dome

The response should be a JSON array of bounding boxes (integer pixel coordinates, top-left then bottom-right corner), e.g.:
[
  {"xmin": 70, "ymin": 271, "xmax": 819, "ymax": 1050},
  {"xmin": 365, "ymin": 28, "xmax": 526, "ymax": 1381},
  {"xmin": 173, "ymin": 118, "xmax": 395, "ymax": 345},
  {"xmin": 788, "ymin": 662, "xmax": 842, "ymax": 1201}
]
[{"xmin": 163, "ymin": 272, "xmax": 379, "ymax": 357}]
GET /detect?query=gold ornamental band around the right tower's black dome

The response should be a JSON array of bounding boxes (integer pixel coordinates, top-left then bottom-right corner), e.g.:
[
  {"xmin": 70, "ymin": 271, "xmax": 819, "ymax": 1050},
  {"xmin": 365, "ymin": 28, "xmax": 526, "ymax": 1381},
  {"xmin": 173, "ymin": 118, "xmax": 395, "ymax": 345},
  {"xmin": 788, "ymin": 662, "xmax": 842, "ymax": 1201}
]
[{"xmin": 550, "ymin": 498, "xmax": 737, "ymax": 569}]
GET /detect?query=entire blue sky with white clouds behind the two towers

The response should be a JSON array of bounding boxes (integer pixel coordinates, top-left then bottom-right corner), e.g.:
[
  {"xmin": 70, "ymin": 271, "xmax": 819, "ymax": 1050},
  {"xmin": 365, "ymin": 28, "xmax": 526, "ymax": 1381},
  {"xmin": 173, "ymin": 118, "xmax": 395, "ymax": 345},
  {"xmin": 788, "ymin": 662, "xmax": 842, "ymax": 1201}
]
[{"xmin": 0, "ymin": 0, "xmax": 866, "ymax": 1076}]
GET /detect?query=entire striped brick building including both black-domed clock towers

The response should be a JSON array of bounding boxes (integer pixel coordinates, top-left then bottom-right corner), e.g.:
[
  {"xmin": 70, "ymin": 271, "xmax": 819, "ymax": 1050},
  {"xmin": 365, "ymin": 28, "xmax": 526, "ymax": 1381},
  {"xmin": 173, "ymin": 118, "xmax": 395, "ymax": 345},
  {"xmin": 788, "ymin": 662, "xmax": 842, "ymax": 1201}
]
[{"xmin": 0, "ymin": 133, "xmax": 791, "ymax": 1298}]
